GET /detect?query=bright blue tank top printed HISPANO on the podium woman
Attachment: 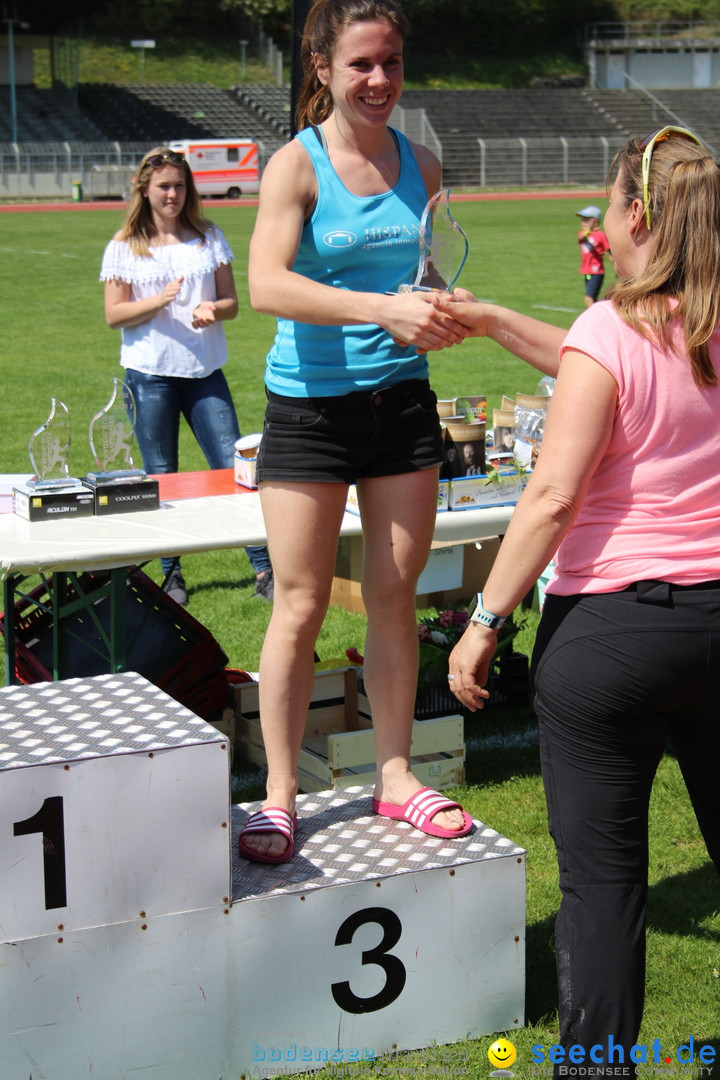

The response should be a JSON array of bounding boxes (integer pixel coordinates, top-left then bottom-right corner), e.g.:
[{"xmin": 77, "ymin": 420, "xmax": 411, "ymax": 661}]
[{"xmin": 266, "ymin": 127, "xmax": 427, "ymax": 397}]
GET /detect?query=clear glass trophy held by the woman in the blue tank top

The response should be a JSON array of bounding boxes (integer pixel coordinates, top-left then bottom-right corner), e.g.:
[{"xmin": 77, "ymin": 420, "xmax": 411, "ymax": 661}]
[{"xmin": 398, "ymin": 188, "xmax": 470, "ymax": 293}]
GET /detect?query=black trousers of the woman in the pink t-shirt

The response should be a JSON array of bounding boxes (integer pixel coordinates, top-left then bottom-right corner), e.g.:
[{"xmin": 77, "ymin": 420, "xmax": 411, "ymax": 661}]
[{"xmin": 532, "ymin": 582, "xmax": 720, "ymax": 1076}]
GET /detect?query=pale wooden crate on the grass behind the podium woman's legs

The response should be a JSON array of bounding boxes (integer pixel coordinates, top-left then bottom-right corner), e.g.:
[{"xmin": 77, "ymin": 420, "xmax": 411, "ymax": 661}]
[{"xmin": 233, "ymin": 667, "xmax": 465, "ymax": 792}]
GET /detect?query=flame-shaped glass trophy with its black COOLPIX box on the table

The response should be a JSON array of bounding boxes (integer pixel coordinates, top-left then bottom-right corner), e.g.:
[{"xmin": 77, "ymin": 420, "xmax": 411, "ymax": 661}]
[{"xmin": 85, "ymin": 378, "xmax": 159, "ymax": 514}]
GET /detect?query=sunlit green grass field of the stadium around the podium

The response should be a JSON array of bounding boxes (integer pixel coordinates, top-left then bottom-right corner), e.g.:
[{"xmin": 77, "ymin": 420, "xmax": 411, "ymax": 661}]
[{"xmin": 0, "ymin": 194, "xmax": 720, "ymax": 1080}]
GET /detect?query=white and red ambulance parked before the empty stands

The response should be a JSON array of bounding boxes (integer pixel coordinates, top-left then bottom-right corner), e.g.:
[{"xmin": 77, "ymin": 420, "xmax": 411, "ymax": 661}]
[{"xmin": 167, "ymin": 138, "xmax": 260, "ymax": 199}]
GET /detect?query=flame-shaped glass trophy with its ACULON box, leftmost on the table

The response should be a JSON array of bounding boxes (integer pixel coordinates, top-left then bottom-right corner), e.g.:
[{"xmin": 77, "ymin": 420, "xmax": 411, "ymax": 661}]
[{"xmin": 13, "ymin": 406, "xmax": 93, "ymax": 522}]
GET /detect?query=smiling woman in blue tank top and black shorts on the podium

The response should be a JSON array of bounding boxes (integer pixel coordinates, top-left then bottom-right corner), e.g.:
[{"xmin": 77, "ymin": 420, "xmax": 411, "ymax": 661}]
[{"xmin": 240, "ymin": 0, "xmax": 472, "ymax": 863}]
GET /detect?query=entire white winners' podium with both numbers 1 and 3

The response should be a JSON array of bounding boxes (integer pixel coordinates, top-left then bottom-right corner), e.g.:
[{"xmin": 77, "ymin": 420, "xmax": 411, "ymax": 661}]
[{"xmin": 0, "ymin": 675, "xmax": 525, "ymax": 1080}]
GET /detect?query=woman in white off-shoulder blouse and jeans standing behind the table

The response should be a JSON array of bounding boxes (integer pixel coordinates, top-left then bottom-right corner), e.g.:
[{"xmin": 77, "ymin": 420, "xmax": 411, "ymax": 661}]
[{"xmin": 100, "ymin": 147, "xmax": 272, "ymax": 603}]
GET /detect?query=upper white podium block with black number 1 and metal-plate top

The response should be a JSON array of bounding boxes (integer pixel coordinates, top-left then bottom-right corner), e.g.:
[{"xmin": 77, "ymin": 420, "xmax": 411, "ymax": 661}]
[{"xmin": 0, "ymin": 672, "xmax": 230, "ymax": 942}]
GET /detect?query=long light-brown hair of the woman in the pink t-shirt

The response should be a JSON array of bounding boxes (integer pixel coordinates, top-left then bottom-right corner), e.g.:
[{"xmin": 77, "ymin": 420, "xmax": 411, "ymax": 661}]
[{"xmin": 608, "ymin": 136, "xmax": 720, "ymax": 387}]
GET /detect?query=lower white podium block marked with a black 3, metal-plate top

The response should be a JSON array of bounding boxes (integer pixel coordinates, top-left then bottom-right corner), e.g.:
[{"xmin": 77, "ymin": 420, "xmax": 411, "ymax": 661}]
[{"xmin": 233, "ymin": 787, "xmax": 526, "ymax": 1076}]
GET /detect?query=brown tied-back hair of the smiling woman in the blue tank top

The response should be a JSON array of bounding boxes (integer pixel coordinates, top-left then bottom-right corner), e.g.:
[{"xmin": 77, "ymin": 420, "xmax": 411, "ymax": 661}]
[{"xmin": 296, "ymin": 0, "xmax": 410, "ymax": 131}]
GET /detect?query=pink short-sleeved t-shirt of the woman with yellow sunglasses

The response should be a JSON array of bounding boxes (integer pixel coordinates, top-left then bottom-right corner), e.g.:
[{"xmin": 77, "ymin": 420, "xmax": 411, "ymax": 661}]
[{"xmin": 548, "ymin": 300, "xmax": 720, "ymax": 595}]
